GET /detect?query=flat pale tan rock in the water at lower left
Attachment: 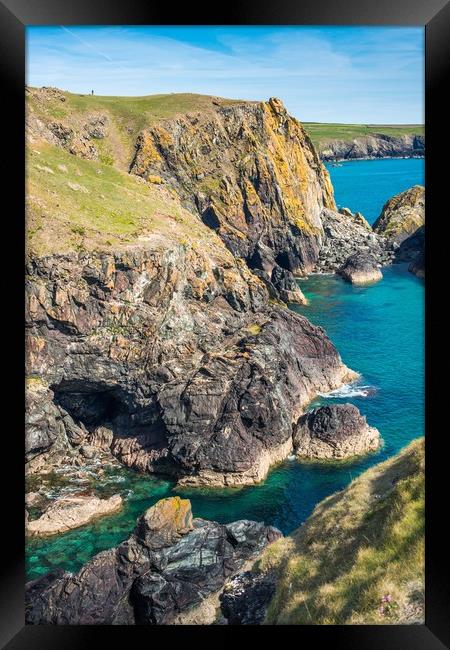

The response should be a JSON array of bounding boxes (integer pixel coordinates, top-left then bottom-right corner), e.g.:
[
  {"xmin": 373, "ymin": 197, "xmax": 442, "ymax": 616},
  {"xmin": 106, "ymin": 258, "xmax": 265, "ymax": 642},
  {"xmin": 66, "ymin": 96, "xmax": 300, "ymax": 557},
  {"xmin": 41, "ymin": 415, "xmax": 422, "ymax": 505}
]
[{"xmin": 26, "ymin": 495, "xmax": 122, "ymax": 536}]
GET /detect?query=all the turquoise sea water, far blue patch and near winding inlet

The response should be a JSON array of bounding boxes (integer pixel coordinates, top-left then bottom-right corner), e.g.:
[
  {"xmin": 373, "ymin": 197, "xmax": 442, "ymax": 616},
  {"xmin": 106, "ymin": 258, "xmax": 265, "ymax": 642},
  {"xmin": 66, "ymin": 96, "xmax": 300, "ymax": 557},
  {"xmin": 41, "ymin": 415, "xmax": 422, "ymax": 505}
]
[{"xmin": 27, "ymin": 160, "xmax": 424, "ymax": 579}]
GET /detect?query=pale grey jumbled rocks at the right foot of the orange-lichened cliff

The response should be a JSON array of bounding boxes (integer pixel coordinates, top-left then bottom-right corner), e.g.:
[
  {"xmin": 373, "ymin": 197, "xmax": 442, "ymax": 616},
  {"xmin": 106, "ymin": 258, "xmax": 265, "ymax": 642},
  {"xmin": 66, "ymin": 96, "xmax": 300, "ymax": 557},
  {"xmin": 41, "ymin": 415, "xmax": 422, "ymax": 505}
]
[{"xmin": 315, "ymin": 208, "xmax": 394, "ymax": 273}]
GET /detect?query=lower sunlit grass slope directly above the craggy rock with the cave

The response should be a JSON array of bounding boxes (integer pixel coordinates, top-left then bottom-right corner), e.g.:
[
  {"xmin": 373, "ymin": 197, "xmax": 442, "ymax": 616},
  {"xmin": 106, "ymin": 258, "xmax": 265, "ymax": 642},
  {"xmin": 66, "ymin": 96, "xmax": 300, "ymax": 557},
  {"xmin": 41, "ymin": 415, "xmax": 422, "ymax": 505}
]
[{"xmin": 25, "ymin": 142, "xmax": 225, "ymax": 256}]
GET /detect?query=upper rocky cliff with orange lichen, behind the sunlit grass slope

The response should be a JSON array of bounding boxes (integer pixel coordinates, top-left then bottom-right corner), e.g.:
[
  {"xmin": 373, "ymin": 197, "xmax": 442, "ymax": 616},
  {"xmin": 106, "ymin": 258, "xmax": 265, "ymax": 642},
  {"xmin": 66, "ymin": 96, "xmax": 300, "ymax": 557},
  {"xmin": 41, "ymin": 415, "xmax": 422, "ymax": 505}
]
[{"xmin": 27, "ymin": 89, "xmax": 342, "ymax": 302}]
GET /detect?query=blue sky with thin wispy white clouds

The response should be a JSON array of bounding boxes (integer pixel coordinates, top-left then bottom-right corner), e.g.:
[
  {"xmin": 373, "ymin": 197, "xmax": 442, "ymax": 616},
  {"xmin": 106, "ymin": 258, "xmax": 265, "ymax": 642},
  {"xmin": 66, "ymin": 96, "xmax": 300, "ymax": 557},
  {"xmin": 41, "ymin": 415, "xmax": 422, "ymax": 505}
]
[{"xmin": 26, "ymin": 25, "xmax": 424, "ymax": 124}]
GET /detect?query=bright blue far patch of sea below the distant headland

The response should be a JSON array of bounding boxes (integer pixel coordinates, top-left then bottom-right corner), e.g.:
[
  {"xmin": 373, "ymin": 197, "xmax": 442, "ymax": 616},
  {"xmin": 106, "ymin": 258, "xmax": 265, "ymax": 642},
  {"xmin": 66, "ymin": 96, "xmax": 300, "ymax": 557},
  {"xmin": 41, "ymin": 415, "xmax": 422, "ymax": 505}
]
[{"xmin": 326, "ymin": 158, "xmax": 425, "ymax": 223}]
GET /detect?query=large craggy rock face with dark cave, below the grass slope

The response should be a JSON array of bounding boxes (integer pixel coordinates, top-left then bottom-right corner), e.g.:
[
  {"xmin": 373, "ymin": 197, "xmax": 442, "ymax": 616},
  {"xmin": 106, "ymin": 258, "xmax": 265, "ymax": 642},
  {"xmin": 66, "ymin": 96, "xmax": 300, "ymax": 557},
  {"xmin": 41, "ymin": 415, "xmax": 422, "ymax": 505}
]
[{"xmin": 26, "ymin": 237, "xmax": 355, "ymax": 485}]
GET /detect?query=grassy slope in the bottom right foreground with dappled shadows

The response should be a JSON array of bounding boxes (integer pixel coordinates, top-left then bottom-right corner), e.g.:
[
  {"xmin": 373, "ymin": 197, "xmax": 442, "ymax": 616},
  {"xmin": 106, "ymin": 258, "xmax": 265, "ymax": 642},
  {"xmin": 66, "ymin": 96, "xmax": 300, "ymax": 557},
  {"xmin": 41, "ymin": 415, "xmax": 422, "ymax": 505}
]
[{"xmin": 259, "ymin": 438, "xmax": 424, "ymax": 625}]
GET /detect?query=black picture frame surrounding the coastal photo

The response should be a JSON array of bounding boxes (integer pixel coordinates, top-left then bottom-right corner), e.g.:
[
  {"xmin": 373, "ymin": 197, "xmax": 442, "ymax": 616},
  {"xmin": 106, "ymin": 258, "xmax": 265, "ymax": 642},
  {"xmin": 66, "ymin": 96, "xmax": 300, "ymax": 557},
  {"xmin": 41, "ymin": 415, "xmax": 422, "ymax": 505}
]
[{"xmin": 0, "ymin": 0, "xmax": 450, "ymax": 650}]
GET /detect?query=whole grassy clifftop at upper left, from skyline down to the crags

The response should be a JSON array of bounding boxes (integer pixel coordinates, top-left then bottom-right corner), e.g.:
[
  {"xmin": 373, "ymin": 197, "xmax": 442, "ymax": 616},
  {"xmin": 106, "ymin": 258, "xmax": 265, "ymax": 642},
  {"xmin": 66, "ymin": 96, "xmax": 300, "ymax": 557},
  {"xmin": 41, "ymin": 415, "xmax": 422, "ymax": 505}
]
[{"xmin": 26, "ymin": 88, "xmax": 250, "ymax": 255}]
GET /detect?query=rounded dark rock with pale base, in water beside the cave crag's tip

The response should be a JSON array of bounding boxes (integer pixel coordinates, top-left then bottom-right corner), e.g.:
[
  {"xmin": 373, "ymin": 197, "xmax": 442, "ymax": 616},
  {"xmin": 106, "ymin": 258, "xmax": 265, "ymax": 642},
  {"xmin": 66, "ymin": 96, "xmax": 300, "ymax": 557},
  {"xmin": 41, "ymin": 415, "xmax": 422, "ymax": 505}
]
[{"xmin": 293, "ymin": 404, "xmax": 381, "ymax": 459}]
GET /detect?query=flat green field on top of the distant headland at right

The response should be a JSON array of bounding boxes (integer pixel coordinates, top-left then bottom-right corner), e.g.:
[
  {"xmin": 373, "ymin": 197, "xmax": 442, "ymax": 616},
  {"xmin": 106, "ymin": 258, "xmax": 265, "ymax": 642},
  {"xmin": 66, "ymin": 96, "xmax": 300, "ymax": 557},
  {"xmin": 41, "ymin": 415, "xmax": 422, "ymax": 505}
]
[{"xmin": 303, "ymin": 122, "xmax": 424, "ymax": 148}]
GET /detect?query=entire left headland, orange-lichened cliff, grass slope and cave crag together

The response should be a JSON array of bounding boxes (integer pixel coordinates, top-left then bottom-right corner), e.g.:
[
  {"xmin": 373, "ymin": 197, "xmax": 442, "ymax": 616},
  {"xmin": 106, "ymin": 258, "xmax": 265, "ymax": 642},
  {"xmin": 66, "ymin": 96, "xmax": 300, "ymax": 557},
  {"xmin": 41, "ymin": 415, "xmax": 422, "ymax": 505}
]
[{"xmin": 26, "ymin": 89, "xmax": 355, "ymax": 485}]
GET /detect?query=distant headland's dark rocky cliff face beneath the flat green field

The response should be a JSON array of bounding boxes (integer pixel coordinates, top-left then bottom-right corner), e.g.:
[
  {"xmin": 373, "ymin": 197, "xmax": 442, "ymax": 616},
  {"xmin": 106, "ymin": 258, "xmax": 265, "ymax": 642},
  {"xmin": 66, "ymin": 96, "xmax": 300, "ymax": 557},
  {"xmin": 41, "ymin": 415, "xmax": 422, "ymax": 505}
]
[{"xmin": 318, "ymin": 133, "xmax": 425, "ymax": 161}]
